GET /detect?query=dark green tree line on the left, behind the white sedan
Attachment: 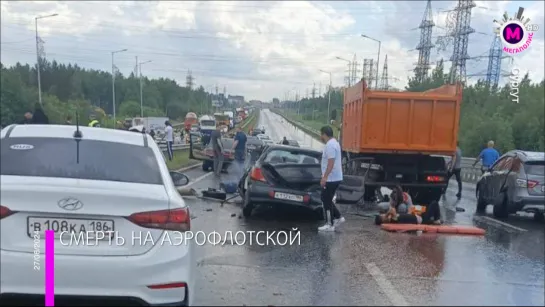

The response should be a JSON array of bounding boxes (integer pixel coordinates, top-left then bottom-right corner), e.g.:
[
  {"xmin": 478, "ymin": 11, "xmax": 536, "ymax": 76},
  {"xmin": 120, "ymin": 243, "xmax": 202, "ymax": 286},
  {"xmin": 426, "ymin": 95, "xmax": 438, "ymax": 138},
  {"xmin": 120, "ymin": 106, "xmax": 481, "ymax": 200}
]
[{"xmin": 0, "ymin": 59, "xmax": 217, "ymax": 126}]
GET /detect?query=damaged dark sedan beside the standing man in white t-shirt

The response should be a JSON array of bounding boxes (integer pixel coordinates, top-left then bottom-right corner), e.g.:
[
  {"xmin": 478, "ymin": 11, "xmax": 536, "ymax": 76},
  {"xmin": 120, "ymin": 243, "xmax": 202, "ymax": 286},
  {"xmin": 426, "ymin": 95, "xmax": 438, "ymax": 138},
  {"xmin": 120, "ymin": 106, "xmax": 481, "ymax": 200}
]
[{"xmin": 239, "ymin": 145, "xmax": 323, "ymax": 217}]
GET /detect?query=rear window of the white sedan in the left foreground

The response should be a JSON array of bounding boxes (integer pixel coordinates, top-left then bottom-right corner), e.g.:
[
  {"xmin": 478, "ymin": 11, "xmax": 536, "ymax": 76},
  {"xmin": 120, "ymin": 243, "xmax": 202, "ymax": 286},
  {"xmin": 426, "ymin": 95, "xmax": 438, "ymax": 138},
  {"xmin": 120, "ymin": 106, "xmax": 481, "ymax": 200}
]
[{"xmin": 0, "ymin": 138, "xmax": 163, "ymax": 184}]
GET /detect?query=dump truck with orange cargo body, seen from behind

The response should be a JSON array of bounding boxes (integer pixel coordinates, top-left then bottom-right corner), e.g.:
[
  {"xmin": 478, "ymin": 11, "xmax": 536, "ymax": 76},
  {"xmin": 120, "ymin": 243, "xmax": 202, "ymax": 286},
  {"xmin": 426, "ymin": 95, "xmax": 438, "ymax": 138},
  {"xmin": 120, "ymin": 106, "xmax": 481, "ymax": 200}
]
[{"xmin": 340, "ymin": 80, "xmax": 462, "ymax": 203}]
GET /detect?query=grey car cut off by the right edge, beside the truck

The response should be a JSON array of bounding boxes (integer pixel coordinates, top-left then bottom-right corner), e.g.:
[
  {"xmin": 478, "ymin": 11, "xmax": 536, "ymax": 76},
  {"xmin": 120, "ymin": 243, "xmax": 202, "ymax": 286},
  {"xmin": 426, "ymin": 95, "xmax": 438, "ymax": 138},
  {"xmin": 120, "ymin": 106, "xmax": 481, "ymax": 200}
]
[{"xmin": 477, "ymin": 150, "xmax": 545, "ymax": 220}]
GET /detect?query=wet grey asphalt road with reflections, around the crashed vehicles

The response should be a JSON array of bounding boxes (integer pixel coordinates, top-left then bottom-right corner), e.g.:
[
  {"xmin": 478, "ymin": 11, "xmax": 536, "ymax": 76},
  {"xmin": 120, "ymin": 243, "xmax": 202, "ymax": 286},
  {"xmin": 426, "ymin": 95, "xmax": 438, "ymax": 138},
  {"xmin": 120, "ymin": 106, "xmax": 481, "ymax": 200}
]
[{"xmin": 181, "ymin": 110, "xmax": 545, "ymax": 306}]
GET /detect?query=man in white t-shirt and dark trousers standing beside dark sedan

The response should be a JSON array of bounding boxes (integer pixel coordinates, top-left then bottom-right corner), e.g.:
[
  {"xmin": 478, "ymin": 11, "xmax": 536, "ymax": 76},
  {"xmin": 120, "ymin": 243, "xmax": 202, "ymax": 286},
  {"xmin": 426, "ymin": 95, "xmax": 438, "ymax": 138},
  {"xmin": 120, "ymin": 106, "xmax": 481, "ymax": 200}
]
[{"xmin": 318, "ymin": 126, "xmax": 344, "ymax": 231}]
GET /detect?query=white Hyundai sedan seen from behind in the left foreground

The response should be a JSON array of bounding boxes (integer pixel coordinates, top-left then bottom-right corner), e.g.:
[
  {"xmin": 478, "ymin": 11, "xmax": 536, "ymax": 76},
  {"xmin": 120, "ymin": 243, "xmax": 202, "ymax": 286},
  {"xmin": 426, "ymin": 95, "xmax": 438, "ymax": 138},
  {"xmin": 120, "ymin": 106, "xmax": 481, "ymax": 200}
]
[{"xmin": 0, "ymin": 125, "xmax": 196, "ymax": 306}]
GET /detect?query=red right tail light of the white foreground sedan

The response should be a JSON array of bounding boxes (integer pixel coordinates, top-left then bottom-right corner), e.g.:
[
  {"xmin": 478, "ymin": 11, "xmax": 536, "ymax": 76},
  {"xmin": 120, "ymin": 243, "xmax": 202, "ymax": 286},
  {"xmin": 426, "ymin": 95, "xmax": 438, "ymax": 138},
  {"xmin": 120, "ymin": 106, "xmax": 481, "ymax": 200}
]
[{"xmin": 128, "ymin": 208, "xmax": 191, "ymax": 231}]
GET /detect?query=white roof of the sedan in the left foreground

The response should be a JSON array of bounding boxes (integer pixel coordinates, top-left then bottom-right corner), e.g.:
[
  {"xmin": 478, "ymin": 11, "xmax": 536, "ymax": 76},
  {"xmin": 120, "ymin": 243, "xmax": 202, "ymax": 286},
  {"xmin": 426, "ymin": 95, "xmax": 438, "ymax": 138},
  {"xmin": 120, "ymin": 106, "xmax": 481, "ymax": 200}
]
[{"xmin": 1, "ymin": 125, "xmax": 152, "ymax": 146}]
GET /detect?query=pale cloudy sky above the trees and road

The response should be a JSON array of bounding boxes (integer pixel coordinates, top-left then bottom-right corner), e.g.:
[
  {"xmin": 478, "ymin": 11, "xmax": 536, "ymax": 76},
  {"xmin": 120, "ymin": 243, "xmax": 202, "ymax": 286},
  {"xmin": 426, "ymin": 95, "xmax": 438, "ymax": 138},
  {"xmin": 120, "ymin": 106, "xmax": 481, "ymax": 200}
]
[{"xmin": 0, "ymin": 1, "xmax": 545, "ymax": 101}]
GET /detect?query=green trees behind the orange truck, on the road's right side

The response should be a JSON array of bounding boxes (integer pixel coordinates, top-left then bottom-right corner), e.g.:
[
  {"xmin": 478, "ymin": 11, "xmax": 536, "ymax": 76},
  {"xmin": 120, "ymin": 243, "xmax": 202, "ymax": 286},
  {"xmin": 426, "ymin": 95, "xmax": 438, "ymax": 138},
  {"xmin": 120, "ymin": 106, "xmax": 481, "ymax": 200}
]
[{"xmin": 282, "ymin": 61, "xmax": 545, "ymax": 156}]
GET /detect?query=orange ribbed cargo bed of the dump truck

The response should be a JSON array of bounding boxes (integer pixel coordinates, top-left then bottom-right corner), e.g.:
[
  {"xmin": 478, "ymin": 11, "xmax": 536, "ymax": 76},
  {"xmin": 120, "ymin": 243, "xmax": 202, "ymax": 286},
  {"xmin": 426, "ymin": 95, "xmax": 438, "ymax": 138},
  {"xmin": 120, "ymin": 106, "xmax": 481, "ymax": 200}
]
[{"xmin": 341, "ymin": 80, "xmax": 462, "ymax": 155}]
